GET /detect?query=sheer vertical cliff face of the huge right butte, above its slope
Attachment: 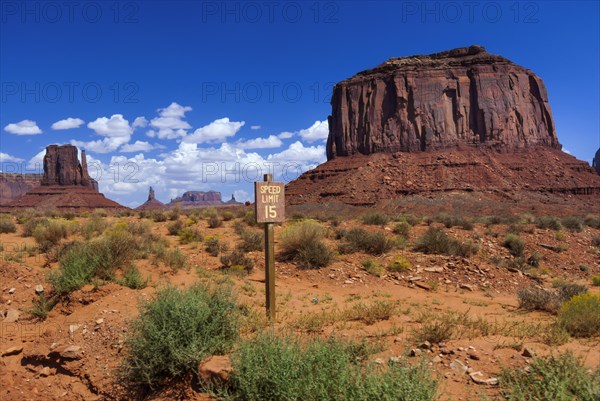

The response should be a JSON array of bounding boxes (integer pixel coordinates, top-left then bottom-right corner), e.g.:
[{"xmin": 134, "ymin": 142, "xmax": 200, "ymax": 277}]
[{"xmin": 327, "ymin": 46, "xmax": 561, "ymax": 160}]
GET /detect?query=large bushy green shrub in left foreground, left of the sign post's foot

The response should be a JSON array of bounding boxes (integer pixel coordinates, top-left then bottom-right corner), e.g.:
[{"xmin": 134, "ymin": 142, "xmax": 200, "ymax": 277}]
[{"xmin": 122, "ymin": 284, "xmax": 238, "ymax": 388}]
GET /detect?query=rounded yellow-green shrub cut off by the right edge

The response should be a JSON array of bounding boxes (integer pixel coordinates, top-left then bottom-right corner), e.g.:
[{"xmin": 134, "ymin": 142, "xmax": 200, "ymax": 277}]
[{"xmin": 558, "ymin": 294, "xmax": 600, "ymax": 337}]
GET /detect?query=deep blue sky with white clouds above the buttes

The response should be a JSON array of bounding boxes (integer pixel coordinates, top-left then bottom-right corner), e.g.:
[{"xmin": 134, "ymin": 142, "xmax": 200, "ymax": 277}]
[{"xmin": 0, "ymin": 0, "xmax": 600, "ymax": 206}]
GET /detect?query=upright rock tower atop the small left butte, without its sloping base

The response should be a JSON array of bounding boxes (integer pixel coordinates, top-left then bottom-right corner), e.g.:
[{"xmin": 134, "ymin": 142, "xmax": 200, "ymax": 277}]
[{"xmin": 42, "ymin": 145, "xmax": 98, "ymax": 191}]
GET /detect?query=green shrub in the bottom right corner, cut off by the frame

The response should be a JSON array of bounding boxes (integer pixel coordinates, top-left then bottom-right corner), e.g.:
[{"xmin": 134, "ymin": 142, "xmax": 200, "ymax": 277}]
[{"xmin": 500, "ymin": 352, "xmax": 600, "ymax": 401}]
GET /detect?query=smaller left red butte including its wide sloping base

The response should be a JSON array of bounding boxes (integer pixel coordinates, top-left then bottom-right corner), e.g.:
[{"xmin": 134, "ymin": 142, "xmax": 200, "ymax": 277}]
[{"xmin": 3, "ymin": 145, "xmax": 125, "ymax": 210}]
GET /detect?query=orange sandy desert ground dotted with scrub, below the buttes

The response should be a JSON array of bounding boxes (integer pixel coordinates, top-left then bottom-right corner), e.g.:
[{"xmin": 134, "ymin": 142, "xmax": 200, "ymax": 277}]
[{"xmin": 0, "ymin": 206, "xmax": 600, "ymax": 401}]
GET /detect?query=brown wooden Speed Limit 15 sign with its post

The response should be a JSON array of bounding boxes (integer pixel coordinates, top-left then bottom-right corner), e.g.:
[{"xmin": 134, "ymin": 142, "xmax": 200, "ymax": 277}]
[{"xmin": 254, "ymin": 174, "xmax": 285, "ymax": 320}]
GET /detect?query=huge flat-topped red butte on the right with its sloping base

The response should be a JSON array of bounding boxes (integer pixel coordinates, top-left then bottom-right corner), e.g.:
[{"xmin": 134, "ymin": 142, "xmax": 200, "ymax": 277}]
[{"xmin": 286, "ymin": 46, "xmax": 600, "ymax": 209}]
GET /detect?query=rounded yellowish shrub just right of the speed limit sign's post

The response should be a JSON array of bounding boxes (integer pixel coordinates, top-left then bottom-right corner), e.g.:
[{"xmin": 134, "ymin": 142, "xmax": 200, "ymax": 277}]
[{"xmin": 278, "ymin": 220, "xmax": 334, "ymax": 269}]
